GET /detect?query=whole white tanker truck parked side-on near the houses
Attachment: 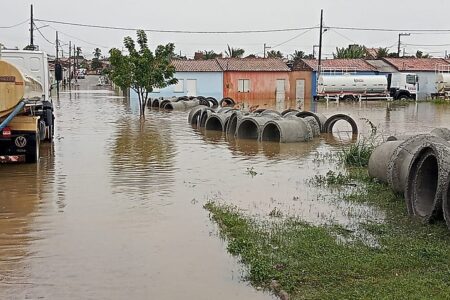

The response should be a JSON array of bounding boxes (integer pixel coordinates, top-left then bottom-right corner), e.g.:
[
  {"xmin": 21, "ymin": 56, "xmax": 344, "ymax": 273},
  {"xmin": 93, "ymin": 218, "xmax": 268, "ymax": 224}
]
[{"xmin": 316, "ymin": 73, "xmax": 417, "ymax": 101}]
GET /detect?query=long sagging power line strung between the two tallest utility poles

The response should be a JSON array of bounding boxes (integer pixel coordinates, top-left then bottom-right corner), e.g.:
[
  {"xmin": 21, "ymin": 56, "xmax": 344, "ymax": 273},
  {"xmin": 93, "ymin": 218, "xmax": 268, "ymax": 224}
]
[{"xmin": 35, "ymin": 19, "xmax": 318, "ymax": 34}]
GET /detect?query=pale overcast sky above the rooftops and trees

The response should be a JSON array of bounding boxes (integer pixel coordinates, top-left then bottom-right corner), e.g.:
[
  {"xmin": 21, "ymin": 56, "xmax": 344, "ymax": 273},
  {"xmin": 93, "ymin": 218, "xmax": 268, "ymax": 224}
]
[{"xmin": 0, "ymin": 0, "xmax": 450, "ymax": 57}]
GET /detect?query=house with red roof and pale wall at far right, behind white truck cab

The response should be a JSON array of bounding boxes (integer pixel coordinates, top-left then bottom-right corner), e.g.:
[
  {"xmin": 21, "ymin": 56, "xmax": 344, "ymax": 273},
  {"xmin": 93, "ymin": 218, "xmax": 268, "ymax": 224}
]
[{"xmin": 383, "ymin": 57, "xmax": 450, "ymax": 100}]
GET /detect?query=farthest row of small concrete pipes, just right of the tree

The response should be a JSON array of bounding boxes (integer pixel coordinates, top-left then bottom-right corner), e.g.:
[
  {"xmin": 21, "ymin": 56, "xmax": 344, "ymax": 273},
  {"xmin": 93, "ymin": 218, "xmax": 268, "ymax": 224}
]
[{"xmin": 148, "ymin": 96, "xmax": 235, "ymax": 111}]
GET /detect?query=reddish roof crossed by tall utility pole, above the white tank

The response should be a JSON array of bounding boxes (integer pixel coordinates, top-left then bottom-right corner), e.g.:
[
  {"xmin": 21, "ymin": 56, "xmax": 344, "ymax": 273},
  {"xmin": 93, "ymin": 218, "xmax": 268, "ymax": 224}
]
[{"xmin": 303, "ymin": 59, "xmax": 377, "ymax": 72}]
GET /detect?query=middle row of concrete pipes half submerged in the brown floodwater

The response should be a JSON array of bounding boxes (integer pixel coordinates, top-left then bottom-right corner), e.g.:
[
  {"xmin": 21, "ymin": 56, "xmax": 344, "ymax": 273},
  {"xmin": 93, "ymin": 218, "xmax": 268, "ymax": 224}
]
[{"xmin": 188, "ymin": 106, "xmax": 358, "ymax": 143}]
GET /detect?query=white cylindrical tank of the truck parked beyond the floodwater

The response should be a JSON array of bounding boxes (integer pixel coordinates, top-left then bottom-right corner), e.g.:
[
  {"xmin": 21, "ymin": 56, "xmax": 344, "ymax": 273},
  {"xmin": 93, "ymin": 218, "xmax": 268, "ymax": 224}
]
[{"xmin": 318, "ymin": 74, "xmax": 388, "ymax": 94}]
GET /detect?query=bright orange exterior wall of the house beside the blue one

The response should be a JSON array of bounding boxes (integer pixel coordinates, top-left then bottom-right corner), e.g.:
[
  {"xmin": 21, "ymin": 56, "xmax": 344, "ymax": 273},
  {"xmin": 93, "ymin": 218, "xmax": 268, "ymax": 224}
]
[{"xmin": 223, "ymin": 71, "xmax": 295, "ymax": 104}]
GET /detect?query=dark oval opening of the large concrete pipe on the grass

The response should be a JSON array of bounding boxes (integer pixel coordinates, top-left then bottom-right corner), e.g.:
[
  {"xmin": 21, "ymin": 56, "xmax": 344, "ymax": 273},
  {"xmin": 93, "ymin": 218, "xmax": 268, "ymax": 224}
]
[{"xmin": 413, "ymin": 152, "xmax": 439, "ymax": 216}]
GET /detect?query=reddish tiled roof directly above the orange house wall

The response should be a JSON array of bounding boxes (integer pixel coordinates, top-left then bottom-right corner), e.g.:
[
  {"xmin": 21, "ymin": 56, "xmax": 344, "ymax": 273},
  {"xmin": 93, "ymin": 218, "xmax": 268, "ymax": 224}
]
[{"xmin": 217, "ymin": 58, "xmax": 290, "ymax": 72}]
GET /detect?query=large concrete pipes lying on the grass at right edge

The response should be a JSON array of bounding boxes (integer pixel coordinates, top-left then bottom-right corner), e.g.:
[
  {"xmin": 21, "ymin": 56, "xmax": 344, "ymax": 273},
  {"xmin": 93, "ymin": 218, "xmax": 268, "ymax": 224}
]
[{"xmin": 369, "ymin": 128, "xmax": 450, "ymax": 229}]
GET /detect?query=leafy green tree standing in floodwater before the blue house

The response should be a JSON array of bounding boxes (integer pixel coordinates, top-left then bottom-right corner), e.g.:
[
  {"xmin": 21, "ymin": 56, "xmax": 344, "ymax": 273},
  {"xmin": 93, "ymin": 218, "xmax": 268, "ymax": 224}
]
[{"xmin": 109, "ymin": 30, "xmax": 178, "ymax": 117}]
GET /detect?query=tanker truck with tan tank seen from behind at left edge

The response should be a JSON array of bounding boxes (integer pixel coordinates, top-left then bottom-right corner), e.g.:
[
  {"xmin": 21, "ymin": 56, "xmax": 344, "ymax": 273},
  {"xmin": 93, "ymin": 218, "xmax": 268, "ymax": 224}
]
[{"xmin": 0, "ymin": 49, "xmax": 54, "ymax": 163}]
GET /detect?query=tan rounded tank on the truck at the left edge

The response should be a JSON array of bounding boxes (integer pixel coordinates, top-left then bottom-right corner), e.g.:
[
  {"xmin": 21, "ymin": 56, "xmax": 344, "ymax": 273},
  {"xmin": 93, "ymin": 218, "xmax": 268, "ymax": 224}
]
[{"xmin": 0, "ymin": 60, "xmax": 43, "ymax": 117}]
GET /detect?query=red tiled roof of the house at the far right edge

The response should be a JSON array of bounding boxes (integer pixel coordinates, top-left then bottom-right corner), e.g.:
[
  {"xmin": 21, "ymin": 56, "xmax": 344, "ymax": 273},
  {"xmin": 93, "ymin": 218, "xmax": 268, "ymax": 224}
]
[{"xmin": 383, "ymin": 57, "xmax": 449, "ymax": 72}]
